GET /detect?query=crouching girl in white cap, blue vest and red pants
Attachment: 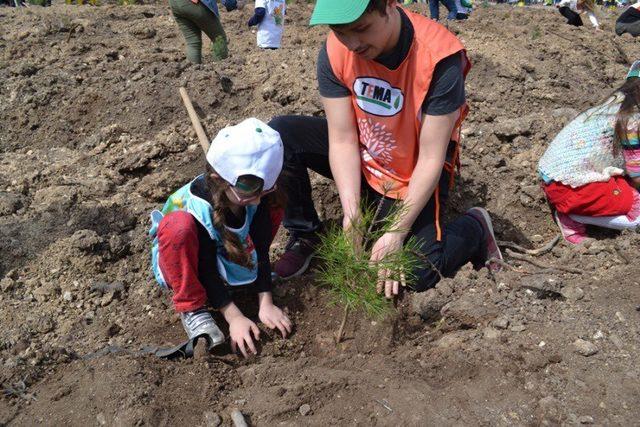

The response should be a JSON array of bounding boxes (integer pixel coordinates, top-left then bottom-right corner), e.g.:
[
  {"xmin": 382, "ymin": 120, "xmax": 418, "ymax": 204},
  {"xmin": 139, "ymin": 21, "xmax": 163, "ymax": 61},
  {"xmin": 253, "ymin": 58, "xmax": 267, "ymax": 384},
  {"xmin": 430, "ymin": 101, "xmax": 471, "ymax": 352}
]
[{"xmin": 150, "ymin": 118, "xmax": 292, "ymax": 357}]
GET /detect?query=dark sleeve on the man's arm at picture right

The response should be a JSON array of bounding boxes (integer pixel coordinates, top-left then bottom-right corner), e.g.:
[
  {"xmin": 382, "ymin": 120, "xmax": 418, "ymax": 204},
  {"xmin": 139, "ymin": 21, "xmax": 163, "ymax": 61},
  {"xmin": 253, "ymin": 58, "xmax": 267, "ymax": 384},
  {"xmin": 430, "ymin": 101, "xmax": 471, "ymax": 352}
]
[{"xmin": 422, "ymin": 52, "xmax": 465, "ymax": 116}]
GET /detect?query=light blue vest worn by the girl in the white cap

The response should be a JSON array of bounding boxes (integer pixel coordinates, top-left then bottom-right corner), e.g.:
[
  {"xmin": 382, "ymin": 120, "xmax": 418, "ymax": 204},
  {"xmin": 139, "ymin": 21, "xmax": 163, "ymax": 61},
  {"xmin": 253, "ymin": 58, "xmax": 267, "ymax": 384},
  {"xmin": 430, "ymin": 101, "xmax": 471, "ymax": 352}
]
[{"xmin": 149, "ymin": 175, "xmax": 258, "ymax": 288}]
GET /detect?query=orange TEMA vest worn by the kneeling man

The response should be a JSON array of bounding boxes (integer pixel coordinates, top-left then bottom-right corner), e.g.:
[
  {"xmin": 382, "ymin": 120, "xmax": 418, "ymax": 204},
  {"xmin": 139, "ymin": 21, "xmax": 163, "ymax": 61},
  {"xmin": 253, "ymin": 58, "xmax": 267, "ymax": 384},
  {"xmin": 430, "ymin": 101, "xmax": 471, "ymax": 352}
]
[{"xmin": 327, "ymin": 11, "xmax": 471, "ymax": 199}]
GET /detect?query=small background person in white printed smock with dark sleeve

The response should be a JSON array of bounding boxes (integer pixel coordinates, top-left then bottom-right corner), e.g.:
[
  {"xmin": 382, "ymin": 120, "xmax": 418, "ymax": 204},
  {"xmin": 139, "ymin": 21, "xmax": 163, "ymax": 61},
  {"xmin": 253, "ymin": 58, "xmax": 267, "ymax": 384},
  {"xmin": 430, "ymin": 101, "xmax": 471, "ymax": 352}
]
[{"xmin": 248, "ymin": 0, "xmax": 287, "ymax": 49}]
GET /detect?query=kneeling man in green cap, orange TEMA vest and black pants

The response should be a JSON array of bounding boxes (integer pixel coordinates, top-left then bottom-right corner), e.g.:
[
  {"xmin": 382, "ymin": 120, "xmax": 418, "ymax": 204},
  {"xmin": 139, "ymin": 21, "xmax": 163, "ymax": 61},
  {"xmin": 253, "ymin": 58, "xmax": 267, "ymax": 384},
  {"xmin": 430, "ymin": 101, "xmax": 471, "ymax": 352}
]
[{"xmin": 270, "ymin": 0, "xmax": 500, "ymax": 297}]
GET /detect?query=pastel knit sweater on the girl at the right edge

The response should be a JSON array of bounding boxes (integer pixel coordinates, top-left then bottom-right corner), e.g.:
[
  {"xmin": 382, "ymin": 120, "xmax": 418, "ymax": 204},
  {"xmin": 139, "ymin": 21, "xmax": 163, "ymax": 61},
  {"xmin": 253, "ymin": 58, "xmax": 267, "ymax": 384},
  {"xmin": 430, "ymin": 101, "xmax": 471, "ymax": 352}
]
[{"xmin": 538, "ymin": 98, "xmax": 640, "ymax": 188}]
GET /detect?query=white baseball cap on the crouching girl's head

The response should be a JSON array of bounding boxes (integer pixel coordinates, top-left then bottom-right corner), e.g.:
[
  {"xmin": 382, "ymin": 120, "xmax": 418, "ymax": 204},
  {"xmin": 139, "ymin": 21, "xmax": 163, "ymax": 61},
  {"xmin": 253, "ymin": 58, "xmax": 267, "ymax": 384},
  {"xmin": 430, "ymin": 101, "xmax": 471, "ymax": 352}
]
[{"xmin": 207, "ymin": 117, "xmax": 284, "ymax": 190}]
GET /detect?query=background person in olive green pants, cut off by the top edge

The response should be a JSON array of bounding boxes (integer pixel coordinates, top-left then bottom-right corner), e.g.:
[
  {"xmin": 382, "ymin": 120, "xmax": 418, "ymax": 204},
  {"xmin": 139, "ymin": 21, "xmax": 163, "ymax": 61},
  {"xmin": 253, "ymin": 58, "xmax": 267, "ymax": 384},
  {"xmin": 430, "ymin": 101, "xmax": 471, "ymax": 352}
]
[{"xmin": 169, "ymin": 0, "xmax": 239, "ymax": 64}]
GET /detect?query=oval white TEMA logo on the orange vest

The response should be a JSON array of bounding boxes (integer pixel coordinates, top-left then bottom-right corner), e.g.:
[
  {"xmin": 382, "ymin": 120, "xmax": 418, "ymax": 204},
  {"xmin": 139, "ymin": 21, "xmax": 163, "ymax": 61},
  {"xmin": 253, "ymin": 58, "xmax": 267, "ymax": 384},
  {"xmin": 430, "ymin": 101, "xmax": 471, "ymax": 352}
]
[{"xmin": 353, "ymin": 77, "xmax": 404, "ymax": 116}]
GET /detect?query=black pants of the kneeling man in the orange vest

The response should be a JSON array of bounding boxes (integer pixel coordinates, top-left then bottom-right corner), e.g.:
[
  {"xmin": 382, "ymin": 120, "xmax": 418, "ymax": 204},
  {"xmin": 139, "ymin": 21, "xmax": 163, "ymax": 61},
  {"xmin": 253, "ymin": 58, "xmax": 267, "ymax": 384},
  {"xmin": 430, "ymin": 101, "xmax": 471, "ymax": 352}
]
[{"xmin": 269, "ymin": 116, "xmax": 486, "ymax": 292}]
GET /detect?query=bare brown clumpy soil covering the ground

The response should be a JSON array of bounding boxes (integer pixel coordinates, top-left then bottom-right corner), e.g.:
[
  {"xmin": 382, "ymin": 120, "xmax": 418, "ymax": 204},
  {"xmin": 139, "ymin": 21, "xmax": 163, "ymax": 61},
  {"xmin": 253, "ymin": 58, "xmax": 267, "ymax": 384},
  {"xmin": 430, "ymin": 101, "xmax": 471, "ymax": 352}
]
[{"xmin": 0, "ymin": 2, "xmax": 640, "ymax": 426}]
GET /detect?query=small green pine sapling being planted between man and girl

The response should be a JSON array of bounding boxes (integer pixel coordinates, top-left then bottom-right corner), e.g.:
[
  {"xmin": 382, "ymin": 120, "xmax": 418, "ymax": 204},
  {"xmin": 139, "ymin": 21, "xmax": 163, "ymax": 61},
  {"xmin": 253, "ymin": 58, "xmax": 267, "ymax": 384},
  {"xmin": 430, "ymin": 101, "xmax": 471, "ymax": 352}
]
[{"xmin": 316, "ymin": 198, "xmax": 423, "ymax": 343}]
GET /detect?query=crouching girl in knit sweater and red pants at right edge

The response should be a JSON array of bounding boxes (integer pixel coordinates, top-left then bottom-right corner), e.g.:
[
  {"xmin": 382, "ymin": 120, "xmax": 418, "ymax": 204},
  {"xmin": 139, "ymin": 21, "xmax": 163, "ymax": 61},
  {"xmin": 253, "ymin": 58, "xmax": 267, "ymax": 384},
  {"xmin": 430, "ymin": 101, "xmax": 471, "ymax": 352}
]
[{"xmin": 538, "ymin": 61, "xmax": 640, "ymax": 244}]
